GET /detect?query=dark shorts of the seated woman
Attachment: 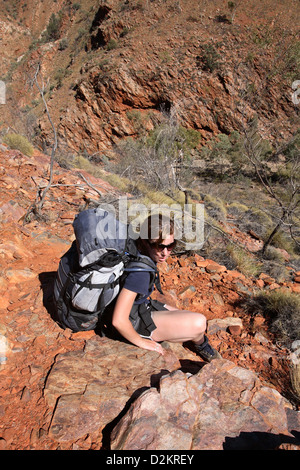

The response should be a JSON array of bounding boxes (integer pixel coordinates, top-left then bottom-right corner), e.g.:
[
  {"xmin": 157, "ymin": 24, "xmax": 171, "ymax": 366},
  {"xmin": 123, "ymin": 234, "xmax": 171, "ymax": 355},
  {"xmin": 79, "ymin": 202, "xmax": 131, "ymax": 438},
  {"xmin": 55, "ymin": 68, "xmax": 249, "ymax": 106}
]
[{"xmin": 129, "ymin": 299, "xmax": 168, "ymax": 338}]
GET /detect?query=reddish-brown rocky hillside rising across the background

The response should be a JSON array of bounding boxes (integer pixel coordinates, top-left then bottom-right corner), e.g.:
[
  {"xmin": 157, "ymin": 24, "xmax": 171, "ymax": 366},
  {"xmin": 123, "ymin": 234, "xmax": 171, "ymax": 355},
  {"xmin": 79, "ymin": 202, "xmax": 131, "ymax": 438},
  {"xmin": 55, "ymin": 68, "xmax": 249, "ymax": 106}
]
[{"xmin": 1, "ymin": 0, "xmax": 299, "ymax": 155}]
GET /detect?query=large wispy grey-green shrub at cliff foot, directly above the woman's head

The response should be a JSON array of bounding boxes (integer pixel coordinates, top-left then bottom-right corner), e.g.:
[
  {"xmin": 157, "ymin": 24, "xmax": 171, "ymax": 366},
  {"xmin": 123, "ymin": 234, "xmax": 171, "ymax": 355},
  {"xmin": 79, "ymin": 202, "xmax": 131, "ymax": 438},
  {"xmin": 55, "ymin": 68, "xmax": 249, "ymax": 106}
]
[{"xmin": 112, "ymin": 114, "xmax": 200, "ymax": 198}]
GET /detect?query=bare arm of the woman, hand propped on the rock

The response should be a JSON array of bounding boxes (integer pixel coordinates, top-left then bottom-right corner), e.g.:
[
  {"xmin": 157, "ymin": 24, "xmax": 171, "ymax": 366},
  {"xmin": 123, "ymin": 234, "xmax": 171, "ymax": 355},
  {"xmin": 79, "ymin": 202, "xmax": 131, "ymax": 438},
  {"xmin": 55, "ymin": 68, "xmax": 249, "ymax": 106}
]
[{"xmin": 112, "ymin": 288, "xmax": 164, "ymax": 354}]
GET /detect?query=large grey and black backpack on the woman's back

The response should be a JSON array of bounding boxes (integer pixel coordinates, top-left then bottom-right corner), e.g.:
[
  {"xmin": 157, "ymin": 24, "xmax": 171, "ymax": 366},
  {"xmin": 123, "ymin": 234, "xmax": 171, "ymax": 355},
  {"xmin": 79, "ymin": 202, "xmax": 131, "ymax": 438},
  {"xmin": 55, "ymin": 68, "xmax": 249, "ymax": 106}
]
[{"xmin": 54, "ymin": 207, "xmax": 161, "ymax": 331}]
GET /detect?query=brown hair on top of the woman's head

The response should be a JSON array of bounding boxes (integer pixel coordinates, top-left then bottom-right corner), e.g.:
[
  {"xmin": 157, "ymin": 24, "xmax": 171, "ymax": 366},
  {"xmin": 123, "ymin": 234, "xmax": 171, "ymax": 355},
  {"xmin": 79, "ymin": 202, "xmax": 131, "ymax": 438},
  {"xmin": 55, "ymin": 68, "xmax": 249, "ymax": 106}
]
[{"xmin": 140, "ymin": 213, "xmax": 175, "ymax": 243}]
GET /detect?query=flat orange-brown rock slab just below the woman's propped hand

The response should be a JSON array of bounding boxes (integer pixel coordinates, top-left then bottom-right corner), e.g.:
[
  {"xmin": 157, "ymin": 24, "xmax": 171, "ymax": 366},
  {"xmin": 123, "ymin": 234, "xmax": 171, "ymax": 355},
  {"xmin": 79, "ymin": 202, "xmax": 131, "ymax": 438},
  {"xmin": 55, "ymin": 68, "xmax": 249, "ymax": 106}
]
[{"xmin": 44, "ymin": 336, "xmax": 180, "ymax": 443}]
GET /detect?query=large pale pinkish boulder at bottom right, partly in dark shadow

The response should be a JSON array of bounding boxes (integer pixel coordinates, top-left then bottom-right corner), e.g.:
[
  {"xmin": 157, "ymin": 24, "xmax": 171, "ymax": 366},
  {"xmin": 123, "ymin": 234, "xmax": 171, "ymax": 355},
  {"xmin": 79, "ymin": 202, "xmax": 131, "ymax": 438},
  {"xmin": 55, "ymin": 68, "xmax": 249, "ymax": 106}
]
[{"xmin": 111, "ymin": 359, "xmax": 300, "ymax": 450}]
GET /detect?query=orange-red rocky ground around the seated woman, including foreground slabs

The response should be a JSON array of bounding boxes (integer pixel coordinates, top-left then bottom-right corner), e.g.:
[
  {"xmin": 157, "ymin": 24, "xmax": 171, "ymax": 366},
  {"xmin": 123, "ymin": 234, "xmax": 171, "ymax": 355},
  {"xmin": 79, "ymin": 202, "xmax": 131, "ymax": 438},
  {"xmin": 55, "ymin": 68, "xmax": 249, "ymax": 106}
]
[{"xmin": 0, "ymin": 147, "xmax": 300, "ymax": 450}]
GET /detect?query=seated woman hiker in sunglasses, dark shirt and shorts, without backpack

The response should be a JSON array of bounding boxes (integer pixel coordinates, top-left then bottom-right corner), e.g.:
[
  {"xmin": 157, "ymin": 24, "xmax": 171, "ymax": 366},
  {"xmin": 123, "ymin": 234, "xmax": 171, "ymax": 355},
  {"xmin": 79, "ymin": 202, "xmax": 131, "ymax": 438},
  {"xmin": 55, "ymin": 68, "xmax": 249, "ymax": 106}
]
[{"xmin": 111, "ymin": 214, "xmax": 221, "ymax": 362}]
